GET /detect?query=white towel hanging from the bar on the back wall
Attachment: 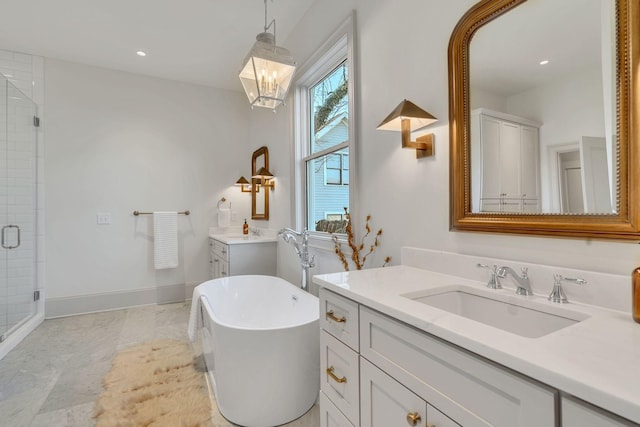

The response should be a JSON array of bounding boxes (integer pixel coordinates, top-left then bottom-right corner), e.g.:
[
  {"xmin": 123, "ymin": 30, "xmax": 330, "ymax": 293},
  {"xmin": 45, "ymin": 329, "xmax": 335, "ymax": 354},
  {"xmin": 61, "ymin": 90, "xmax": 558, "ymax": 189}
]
[{"xmin": 153, "ymin": 212, "xmax": 178, "ymax": 270}]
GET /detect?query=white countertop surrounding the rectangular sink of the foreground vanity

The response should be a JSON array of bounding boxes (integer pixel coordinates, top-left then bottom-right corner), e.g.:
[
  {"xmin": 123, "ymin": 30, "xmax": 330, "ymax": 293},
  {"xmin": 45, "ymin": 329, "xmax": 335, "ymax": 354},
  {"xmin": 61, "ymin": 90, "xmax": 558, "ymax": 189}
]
[{"xmin": 313, "ymin": 266, "xmax": 640, "ymax": 423}]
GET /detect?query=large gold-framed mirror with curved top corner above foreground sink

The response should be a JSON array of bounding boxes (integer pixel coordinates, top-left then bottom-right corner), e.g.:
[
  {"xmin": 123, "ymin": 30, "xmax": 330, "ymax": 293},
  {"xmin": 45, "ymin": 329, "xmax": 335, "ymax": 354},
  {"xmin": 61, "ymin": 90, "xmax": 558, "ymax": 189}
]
[{"xmin": 449, "ymin": 0, "xmax": 640, "ymax": 240}]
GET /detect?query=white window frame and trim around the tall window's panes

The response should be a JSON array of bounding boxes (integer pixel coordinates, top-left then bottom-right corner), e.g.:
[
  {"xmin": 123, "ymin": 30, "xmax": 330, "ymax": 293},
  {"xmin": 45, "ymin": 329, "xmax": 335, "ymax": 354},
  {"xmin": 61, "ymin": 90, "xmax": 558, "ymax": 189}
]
[{"xmin": 291, "ymin": 12, "xmax": 359, "ymax": 244}]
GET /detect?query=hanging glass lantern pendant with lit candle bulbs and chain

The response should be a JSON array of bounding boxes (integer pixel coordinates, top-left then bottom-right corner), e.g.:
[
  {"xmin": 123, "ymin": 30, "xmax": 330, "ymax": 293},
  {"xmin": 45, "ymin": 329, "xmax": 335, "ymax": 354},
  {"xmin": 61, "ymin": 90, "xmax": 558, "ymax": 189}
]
[{"xmin": 239, "ymin": 0, "xmax": 296, "ymax": 110}]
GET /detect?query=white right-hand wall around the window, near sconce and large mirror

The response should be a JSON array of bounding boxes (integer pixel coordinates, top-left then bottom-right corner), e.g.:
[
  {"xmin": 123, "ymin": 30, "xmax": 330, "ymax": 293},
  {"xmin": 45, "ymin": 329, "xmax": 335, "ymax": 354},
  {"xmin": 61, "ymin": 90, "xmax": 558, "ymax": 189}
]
[{"xmin": 252, "ymin": 0, "xmax": 640, "ymax": 298}]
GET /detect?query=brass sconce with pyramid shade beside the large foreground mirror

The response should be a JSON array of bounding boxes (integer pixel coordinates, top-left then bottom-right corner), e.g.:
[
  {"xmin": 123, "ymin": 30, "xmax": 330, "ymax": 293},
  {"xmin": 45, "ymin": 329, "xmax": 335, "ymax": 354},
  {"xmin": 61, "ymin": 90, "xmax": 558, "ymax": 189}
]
[{"xmin": 377, "ymin": 99, "xmax": 438, "ymax": 159}]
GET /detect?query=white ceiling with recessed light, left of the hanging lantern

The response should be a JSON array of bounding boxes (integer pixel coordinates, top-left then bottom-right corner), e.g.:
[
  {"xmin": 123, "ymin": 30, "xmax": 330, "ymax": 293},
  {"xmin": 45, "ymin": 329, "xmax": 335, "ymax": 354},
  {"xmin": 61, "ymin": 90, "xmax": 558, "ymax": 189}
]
[{"xmin": 0, "ymin": 0, "xmax": 314, "ymax": 91}]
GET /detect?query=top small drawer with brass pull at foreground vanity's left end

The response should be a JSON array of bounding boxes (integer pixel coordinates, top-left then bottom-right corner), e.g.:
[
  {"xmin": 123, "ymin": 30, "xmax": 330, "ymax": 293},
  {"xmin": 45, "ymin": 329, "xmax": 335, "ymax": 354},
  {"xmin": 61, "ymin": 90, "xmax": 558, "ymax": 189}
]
[{"xmin": 320, "ymin": 288, "xmax": 359, "ymax": 352}]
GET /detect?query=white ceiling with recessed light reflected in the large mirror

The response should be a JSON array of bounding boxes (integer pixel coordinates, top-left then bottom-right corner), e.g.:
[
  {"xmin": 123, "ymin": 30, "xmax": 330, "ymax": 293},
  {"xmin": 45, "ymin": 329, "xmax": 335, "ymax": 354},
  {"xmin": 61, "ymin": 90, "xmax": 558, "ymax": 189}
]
[{"xmin": 469, "ymin": 0, "xmax": 603, "ymax": 96}]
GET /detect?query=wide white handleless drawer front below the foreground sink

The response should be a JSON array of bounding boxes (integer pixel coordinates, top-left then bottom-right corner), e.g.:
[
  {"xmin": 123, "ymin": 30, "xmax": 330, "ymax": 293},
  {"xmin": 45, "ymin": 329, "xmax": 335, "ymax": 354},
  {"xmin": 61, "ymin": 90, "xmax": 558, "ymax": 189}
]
[{"xmin": 360, "ymin": 307, "xmax": 557, "ymax": 427}]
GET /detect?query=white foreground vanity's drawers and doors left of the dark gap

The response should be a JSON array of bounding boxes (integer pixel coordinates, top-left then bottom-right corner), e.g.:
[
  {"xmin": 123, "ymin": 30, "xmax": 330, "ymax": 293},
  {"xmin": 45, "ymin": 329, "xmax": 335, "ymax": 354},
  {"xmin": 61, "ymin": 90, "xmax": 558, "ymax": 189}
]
[{"xmin": 320, "ymin": 288, "xmax": 558, "ymax": 427}]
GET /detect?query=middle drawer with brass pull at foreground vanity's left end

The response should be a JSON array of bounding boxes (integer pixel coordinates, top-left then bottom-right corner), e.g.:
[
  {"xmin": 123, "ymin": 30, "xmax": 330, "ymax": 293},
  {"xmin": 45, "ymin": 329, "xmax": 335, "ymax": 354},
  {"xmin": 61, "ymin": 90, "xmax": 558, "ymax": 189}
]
[{"xmin": 320, "ymin": 331, "xmax": 360, "ymax": 426}]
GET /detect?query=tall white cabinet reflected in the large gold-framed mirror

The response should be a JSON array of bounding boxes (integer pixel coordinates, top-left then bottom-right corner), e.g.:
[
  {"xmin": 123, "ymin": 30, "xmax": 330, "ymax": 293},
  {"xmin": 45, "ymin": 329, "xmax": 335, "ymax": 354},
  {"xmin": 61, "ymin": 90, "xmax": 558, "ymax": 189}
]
[{"xmin": 471, "ymin": 108, "xmax": 540, "ymax": 212}]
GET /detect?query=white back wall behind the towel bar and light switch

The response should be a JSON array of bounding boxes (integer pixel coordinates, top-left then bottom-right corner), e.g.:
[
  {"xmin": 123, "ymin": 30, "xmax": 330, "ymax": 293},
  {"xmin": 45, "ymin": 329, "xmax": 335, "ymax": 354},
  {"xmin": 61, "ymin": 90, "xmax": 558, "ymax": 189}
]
[{"xmin": 44, "ymin": 59, "xmax": 251, "ymax": 316}]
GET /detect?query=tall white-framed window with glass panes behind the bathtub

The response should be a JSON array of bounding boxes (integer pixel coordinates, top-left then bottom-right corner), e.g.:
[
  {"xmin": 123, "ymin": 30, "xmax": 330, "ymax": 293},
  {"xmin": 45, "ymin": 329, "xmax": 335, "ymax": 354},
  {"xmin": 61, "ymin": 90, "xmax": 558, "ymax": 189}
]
[{"xmin": 295, "ymin": 13, "xmax": 355, "ymax": 236}]
